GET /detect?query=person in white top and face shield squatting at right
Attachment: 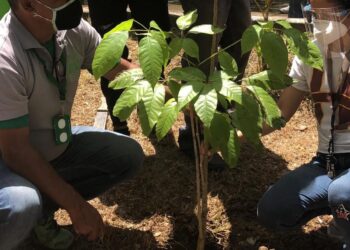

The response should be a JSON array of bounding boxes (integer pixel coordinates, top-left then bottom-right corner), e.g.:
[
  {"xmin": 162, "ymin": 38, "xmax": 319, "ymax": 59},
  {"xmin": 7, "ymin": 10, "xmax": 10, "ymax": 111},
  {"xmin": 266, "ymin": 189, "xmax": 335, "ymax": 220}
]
[{"xmin": 257, "ymin": 0, "xmax": 350, "ymax": 249}]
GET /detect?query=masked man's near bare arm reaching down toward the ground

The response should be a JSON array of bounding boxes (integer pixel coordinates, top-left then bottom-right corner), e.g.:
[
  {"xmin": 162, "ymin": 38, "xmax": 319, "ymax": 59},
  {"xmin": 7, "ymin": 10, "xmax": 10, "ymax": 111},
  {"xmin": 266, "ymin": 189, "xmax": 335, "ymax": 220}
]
[{"xmin": 0, "ymin": 128, "xmax": 103, "ymax": 240}]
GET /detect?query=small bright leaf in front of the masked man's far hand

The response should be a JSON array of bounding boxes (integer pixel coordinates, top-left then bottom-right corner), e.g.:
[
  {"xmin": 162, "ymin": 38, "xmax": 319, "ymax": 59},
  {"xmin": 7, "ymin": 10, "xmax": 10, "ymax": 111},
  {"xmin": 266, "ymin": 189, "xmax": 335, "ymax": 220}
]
[{"xmin": 108, "ymin": 69, "xmax": 143, "ymax": 90}]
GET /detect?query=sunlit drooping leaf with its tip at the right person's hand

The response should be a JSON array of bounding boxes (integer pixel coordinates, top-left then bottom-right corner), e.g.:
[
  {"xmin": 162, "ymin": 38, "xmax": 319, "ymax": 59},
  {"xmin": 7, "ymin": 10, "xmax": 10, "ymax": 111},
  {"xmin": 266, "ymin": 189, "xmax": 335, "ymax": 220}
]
[{"xmin": 247, "ymin": 86, "xmax": 282, "ymax": 128}]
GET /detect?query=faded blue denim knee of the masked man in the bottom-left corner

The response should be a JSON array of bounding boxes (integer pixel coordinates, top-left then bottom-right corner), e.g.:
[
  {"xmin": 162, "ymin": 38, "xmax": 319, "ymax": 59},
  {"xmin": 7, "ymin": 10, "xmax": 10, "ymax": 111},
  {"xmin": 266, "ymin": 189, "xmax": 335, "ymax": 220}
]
[{"xmin": 0, "ymin": 186, "xmax": 42, "ymax": 249}]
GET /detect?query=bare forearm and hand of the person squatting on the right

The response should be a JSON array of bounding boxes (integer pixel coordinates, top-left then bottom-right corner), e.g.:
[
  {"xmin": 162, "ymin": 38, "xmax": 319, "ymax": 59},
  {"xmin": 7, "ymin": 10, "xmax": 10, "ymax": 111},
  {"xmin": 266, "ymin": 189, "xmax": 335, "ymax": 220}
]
[{"xmin": 262, "ymin": 86, "xmax": 307, "ymax": 135}]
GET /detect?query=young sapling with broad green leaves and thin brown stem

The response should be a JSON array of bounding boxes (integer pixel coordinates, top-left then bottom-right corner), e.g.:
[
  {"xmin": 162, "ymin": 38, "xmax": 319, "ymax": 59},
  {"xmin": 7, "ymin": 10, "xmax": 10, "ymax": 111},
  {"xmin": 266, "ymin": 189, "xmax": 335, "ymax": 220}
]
[{"xmin": 93, "ymin": 9, "xmax": 322, "ymax": 249}]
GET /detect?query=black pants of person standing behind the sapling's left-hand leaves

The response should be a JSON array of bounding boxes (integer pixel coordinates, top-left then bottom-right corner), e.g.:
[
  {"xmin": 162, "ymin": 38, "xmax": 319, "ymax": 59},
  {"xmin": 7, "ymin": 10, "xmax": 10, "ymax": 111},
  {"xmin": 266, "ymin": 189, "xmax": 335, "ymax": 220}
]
[{"xmin": 88, "ymin": 0, "xmax": 170, "ymax": 127}]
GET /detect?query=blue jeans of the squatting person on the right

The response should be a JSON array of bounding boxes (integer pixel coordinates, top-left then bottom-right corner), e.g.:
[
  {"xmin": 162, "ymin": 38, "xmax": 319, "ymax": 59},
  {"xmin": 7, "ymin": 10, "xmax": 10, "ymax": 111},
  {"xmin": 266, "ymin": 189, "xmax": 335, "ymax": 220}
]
[{"xmin": 257, "ymin": 154, "xmax": 350, "ymax": 243}]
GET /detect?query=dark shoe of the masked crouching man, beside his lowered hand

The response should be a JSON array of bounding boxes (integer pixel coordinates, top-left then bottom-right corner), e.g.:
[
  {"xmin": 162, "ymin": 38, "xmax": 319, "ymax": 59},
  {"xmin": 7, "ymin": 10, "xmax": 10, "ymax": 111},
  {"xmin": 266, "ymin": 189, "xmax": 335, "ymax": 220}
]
[{"xmin": 33, "ymin": 217, "xmax": 74, "ymax": 250}]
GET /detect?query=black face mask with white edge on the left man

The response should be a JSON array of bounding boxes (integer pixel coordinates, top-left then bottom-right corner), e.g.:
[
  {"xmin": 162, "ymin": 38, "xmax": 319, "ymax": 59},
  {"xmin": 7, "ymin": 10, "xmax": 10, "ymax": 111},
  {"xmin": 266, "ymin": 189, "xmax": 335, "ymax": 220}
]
[{"xmin": 35, "ymin": 0, "xmax": 83, "ymax": 31}]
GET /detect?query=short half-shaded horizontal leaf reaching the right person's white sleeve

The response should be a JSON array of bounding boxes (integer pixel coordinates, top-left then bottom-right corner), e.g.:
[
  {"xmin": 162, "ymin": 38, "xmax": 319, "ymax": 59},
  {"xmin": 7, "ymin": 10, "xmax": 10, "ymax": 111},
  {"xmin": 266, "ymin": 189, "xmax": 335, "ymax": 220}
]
[{"xmin": 248, "ymin": 70, "xmax": 293, "ymax": 90}]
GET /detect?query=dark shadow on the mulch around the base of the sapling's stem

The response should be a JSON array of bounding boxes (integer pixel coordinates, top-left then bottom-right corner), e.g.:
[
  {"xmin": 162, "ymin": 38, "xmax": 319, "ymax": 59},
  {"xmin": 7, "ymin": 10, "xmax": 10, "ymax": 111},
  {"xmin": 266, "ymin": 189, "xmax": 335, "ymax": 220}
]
[{"xmin": 94, "ymin": 131, "xmax": 340, "ymax": 250}]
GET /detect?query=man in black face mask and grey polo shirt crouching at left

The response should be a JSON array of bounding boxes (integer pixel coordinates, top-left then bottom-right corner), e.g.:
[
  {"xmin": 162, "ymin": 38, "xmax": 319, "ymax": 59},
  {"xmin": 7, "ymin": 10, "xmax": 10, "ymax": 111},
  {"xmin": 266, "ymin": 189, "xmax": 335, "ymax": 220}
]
[{"xmin": 0, "ymin": 0, "xmax": 144, "ymax": 250}]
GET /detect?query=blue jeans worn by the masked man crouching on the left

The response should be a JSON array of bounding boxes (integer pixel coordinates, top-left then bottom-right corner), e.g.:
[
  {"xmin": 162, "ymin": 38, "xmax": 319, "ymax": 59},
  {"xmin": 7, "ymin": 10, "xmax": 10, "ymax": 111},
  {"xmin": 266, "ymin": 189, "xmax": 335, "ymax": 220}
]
[{"xmin": 0, "ymin": 127, "xmax": 144, "ymax": 250}]
